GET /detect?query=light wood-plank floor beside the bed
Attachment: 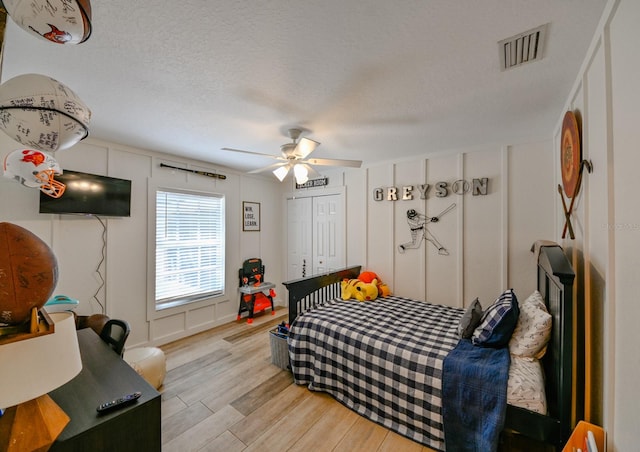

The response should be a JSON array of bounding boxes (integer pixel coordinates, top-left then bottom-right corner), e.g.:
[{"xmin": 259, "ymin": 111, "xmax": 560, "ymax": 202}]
[{"xmin": 160, "ymin": 309, "xmax": 431, "ymax": 452}]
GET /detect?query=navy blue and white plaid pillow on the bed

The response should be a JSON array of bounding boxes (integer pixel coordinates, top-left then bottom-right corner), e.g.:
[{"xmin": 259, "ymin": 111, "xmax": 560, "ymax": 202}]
[{"xmin": 471, "ymin": 289, "xmax": 520, "ymax": 347}]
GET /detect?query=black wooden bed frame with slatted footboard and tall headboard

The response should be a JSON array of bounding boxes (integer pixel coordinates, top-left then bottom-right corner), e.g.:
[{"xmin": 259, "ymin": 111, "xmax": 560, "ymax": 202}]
[{"xmin": 283, "ymin": 246, "xmax": 582, "ymax": 450}]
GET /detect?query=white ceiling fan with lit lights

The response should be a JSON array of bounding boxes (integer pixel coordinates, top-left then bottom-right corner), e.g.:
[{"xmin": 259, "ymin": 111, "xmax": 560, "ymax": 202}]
[{"xmin": 222, "ymin": 129, "xmax": 362, "ymax": 184}]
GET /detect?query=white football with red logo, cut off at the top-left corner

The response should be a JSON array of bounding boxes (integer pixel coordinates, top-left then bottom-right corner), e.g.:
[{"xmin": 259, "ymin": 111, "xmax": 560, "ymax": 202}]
[{"xmin": 3, "ymin": 0, "xmax": 91, "ymax": 44}]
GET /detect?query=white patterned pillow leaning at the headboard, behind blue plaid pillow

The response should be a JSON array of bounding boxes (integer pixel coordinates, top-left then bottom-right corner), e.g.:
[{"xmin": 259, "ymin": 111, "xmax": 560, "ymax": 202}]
[{"xmin": 509, "ymin": 290, "xmax": 552, "ymax": 359}]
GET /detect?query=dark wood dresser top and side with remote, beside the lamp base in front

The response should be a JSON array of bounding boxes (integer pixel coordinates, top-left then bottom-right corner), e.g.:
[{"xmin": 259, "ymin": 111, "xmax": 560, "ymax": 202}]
[{"xmin": 49, "ymin": 328, "xmax": 162, "ymax": 452}]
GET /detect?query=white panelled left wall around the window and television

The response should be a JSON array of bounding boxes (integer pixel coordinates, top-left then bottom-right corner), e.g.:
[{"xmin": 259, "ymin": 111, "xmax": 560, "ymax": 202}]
[{"xmin": 0, "ymin": 134, "xmax": 285, "ymax": 347}]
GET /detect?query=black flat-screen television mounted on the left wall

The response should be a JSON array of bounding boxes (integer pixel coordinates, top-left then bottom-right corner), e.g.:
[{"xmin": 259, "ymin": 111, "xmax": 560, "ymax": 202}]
[{"xmin": 40, "ymin": 169, "xmax": 131, "ymax": 217}]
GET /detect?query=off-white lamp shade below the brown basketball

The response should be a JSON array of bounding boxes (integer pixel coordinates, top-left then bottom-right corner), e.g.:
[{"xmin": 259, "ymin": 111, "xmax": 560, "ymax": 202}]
[{"xmin": 0, "ymin": 312, "xmax": 82, "ymax": 408}]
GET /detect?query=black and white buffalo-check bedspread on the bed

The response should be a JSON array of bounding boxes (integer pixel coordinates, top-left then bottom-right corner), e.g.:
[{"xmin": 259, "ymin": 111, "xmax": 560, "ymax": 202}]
[{"xmin": 289, "ymin": 296, "xmax": 464, "ymax": 450}]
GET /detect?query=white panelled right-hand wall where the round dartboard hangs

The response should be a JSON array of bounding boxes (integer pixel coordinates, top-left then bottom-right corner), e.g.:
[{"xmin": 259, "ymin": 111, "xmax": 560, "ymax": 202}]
[{"xmin": 555, "ymin": 0, "xmax": 640, "ymax": 451}]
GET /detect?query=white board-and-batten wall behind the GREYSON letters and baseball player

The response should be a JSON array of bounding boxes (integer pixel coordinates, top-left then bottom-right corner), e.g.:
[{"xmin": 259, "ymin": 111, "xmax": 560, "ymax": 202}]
[{"xmin": 316, "ymin": 139, "xmax": 556, "ymax": 307}]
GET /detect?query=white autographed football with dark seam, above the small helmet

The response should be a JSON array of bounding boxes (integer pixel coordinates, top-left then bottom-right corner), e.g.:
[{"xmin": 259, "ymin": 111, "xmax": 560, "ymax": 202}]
[{"xmin": 0, "ymin": 74, "xmax": 91, "ymax": 152}]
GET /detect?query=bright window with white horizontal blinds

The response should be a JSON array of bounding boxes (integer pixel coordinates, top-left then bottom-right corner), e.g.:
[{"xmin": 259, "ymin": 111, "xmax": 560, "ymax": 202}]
[{"xmin": 155, "ymin": 189, "xmax": 225, "ymax": 310}]
